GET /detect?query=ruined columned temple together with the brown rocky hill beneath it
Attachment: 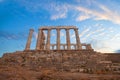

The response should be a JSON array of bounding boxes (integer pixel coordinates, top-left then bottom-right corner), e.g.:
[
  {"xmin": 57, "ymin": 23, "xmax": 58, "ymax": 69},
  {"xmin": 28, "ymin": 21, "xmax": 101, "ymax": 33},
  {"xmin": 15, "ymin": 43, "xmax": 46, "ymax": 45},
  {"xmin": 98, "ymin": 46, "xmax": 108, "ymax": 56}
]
[{"xmin": 0, "ymin": 26, "xmax": 120, "ymax": 80}]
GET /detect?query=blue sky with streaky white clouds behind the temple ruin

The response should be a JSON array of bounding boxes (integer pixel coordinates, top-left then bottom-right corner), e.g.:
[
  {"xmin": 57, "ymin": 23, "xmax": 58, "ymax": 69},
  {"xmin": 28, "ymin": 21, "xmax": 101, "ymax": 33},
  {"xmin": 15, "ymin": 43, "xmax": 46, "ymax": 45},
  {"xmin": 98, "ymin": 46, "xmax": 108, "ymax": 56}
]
[{"xmin": 0, "ymin": 0, "xmax": 120, "ymax": 56}]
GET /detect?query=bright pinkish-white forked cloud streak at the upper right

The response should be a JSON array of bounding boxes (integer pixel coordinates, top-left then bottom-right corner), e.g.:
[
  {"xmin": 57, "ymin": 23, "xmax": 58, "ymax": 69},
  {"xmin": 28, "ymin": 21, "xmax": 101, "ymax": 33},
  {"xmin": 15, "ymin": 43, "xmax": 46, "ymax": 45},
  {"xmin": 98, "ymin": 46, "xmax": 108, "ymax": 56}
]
[{"xmin": 74, "ymin": 4, "xmax": 120, "ymax": 24}]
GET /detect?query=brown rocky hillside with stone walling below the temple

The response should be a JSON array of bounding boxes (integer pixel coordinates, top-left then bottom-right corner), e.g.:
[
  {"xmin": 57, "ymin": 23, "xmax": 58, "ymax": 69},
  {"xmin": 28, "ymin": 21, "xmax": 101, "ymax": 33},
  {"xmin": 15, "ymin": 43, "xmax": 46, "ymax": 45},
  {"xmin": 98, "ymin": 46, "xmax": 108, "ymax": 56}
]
[{"xmin": 0, "ymin": 50, "xmax": 120, "ymax": 80}]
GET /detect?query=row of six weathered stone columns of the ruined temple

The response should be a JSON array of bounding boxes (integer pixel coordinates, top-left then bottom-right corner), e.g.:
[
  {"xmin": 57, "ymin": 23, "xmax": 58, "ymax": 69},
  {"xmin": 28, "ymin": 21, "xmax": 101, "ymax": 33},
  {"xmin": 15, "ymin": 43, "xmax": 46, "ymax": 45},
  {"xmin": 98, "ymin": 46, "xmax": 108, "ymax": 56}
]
[{"xmin": 25, "ymin": 28, "xmax": 82, "ymax": 50}]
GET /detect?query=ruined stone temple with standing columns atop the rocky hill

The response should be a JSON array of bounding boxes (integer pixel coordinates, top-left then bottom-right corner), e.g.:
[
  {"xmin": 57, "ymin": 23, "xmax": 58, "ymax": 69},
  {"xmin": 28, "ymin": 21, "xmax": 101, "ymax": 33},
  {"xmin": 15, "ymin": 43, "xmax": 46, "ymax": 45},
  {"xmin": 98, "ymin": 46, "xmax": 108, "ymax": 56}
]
[{"xmin": 25, "ymin": 26, "xmax": 92, "ymax": 51}]
